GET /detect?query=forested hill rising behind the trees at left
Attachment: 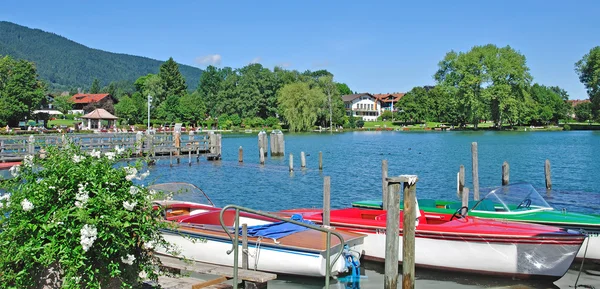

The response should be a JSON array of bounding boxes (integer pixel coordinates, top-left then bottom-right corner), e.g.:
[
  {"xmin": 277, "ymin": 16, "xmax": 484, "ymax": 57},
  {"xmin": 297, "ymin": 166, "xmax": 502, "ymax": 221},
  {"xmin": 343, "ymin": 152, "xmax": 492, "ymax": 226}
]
[{"xmin": 0, "ymin": 21, "xmax": 202, "ymax": 89}]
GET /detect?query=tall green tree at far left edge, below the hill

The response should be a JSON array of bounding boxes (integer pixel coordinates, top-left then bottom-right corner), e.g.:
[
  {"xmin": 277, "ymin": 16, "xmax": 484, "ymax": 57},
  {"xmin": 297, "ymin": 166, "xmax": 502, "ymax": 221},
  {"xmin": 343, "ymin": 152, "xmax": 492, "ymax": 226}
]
[{"xmin": 0, "ymin": 56, "xmax": 46, "ymax": 126}]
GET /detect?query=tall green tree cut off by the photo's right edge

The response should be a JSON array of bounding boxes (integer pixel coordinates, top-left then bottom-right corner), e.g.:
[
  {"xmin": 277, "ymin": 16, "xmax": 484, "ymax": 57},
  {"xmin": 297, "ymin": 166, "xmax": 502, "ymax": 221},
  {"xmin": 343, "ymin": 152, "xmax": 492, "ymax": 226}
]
[{"xmin": 575, "ymin": 46, "xmax": 600, "ymax": 115}]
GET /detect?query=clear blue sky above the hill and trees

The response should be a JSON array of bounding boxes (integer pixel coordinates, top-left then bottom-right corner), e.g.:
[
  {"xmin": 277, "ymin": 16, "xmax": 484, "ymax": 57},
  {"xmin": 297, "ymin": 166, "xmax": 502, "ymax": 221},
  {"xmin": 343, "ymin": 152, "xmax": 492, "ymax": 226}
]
[{"xmin": 0, "ymin": 0, "xmax": 600, "ymax": 99}]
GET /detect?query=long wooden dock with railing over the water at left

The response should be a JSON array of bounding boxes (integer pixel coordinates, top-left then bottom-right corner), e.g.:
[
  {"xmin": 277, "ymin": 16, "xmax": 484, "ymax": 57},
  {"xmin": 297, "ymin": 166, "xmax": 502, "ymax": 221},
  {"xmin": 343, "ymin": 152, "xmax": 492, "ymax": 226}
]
[{"xmin": 0, "ymin": 132, "xmax": 221, "ymax": 163}]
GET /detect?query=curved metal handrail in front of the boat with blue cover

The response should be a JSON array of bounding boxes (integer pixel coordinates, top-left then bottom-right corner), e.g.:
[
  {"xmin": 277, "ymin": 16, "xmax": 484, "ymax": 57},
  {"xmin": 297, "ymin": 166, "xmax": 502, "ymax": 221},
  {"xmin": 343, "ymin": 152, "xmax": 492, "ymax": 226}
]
[{"xmin": 219, "ymin": 205, "xmax": 345, "ymax": 288}]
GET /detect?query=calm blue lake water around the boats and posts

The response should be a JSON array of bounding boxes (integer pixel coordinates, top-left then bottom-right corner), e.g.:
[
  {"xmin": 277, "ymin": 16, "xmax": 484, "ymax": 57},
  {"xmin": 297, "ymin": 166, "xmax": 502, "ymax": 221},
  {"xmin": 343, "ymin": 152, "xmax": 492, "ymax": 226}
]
[{"xmin": 151, "ymin": 131, "xmax": 600, "ymax": 288}]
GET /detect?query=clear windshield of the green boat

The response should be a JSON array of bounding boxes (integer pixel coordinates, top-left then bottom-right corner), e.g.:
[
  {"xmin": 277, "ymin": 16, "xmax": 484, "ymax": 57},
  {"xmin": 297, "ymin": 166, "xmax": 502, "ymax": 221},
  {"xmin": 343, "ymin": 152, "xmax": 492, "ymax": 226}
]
[{"xmin": 472, "ymin": 183, "xmax": 553, "ymax": 212}]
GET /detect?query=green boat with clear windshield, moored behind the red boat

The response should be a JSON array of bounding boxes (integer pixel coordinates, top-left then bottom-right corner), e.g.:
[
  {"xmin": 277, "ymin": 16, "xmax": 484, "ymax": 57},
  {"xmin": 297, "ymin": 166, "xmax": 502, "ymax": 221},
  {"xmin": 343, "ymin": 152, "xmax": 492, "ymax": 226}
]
[{"xmin": 352, "ymin": 183, "xmax": 600, "ymax": 260}]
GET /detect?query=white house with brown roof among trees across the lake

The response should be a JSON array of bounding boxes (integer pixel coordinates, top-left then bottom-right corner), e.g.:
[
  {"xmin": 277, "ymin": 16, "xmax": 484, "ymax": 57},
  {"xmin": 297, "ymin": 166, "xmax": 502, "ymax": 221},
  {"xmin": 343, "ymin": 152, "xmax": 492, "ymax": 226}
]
[{"xmin": 342, "ymin": 93, "xmax": 383, "ymax": 121}]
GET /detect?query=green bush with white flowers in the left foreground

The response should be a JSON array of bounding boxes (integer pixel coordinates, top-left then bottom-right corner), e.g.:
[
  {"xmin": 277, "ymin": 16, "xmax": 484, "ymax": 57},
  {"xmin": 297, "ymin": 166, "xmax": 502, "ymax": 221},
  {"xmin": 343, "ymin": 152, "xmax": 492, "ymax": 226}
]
[{"xmin": 0, "ymin": 145, "xmax": 176, "ymax": 288}]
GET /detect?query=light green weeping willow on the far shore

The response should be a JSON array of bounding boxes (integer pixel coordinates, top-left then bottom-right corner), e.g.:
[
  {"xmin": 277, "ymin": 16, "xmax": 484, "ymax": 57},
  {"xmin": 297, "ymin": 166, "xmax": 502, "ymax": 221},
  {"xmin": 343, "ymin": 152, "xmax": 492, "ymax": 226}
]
[{"xmin": 277, "ymin": 82, "xmax": 326, "ymax": 132}]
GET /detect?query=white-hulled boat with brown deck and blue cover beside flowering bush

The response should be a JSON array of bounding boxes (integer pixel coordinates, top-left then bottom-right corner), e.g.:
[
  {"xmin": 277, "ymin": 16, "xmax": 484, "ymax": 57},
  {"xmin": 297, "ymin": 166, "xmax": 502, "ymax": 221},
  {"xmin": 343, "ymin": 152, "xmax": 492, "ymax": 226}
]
[{"xmin": 149, "ymin": 183, "xmax": 365, "ymax": 277}]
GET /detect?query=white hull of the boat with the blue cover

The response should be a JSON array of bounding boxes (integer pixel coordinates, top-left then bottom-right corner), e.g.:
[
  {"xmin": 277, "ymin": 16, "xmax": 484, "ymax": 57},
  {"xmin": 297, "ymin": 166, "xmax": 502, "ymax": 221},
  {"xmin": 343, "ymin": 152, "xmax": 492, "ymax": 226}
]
[{"xmin": 157, "ymin": 227, "xmax": 363, "ymax": 277}]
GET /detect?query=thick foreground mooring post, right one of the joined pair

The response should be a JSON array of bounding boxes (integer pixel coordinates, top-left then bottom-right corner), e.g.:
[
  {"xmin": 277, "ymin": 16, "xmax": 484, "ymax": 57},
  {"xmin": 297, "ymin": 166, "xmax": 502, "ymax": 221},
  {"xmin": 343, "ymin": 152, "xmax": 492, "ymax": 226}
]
[{"xmin": 401, "ymin": 175, "xmax": 418, "ymax": 289}]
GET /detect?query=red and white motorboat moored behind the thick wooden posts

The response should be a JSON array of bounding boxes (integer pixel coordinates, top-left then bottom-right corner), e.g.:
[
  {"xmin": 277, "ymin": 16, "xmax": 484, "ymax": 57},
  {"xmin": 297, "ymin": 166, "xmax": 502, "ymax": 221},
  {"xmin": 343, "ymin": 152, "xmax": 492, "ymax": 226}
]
[{"xmin": 279, "ymin": 204, "xmax": 585, "ymax": 280}]
